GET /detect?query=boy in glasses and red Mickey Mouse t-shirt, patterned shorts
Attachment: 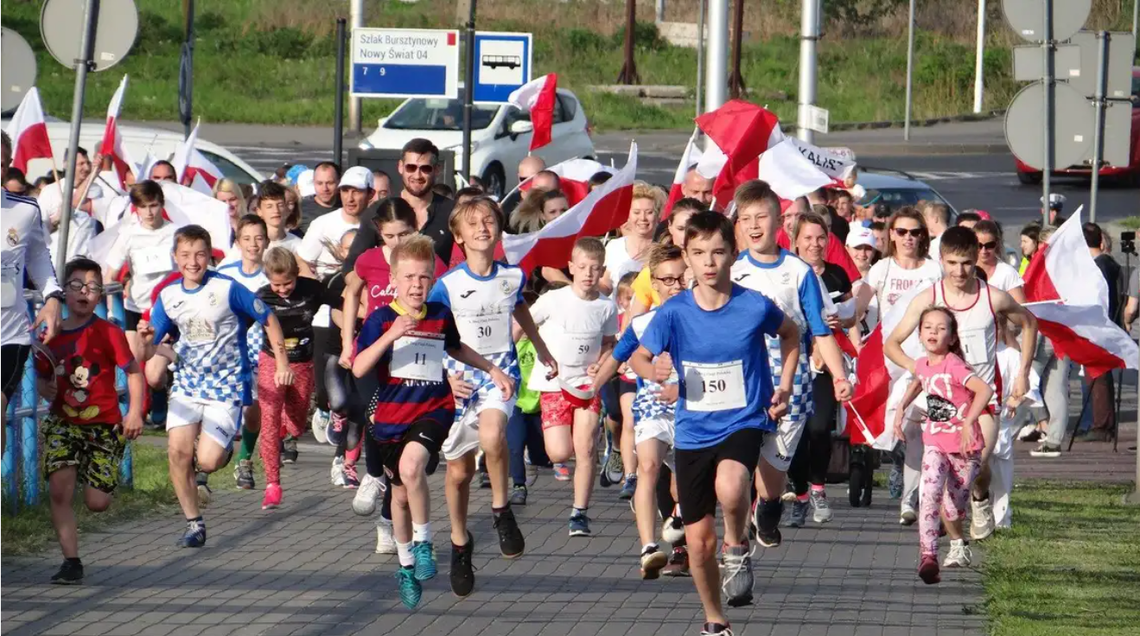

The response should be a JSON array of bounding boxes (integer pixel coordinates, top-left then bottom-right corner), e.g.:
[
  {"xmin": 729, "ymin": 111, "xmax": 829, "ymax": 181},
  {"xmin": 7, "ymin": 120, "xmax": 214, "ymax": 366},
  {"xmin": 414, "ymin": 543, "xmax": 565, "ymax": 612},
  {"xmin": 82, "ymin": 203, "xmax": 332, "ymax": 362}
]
[{"xmin": 35, "ymin": 258, "xmax": 146, "ymax": 585}]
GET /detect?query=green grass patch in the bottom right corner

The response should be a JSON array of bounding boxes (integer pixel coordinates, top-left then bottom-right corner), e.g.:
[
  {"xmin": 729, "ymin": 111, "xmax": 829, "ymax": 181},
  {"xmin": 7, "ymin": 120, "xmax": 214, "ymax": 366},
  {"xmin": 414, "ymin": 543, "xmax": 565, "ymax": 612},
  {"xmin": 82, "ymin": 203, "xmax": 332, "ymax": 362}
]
[{"xmin": 984, "ymin": 482, "xmax": 1140, "ymax": 636}]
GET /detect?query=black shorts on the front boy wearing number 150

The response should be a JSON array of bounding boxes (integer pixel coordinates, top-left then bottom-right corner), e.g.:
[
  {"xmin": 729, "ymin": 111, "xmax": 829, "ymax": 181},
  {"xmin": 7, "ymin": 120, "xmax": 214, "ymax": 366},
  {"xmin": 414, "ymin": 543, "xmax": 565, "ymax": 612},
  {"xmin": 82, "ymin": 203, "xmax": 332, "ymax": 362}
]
[{"xmin": 674, "ymin": 429, "xmax": 764, "ymax": 525}]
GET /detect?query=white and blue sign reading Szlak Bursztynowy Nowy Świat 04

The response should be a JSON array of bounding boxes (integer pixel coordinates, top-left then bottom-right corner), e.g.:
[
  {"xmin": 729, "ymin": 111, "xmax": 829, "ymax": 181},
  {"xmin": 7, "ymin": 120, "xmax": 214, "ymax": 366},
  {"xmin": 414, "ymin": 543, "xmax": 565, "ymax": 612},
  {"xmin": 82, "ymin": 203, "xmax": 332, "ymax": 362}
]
[{"xmin": 349, "ymin": 28, "xmax": 459, "ymax": 99}]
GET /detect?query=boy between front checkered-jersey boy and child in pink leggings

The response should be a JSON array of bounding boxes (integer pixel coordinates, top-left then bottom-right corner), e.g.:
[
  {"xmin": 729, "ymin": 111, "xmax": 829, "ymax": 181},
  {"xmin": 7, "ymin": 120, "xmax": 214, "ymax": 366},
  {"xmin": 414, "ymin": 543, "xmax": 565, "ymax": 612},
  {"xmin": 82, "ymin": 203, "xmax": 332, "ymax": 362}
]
[{"xmin": 214, "ymin": 214, "xmax": 269, "ymax": 499}]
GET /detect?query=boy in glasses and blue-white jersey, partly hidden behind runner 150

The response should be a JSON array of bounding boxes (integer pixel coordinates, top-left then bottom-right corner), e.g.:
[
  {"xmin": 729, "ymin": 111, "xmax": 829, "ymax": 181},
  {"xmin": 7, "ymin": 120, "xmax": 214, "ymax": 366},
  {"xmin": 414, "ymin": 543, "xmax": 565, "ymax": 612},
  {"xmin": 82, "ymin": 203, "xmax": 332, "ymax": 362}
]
[{"xmin": 594, "ymin": 245, "xmax": 689, "ymax": 579}]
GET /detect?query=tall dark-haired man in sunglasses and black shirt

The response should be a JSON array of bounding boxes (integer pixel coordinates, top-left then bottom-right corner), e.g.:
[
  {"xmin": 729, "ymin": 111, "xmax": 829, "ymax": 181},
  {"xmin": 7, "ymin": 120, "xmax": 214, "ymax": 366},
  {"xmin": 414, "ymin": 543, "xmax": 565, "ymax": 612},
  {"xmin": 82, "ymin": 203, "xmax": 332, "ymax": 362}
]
[{"xmin": 343, "ymin": 138, "xmax": 455, "ymax": 270}]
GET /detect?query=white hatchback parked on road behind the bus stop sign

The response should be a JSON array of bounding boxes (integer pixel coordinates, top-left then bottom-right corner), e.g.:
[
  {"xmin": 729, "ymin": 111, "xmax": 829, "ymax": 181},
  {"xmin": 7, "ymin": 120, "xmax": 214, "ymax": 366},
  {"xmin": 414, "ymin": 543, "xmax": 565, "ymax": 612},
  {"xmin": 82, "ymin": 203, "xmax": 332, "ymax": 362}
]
[{"xmin": 361, "ymin": 87, "xmax": 594, "ymax": 197}]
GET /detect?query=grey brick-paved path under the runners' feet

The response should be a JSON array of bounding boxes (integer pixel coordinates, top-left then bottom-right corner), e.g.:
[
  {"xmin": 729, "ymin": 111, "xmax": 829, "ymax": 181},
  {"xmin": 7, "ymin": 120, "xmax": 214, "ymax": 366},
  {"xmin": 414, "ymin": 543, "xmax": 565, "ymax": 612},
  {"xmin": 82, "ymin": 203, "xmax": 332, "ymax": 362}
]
[{"xmin": 0, "ymin": 445, "xmax": 985, "ymax": 636}]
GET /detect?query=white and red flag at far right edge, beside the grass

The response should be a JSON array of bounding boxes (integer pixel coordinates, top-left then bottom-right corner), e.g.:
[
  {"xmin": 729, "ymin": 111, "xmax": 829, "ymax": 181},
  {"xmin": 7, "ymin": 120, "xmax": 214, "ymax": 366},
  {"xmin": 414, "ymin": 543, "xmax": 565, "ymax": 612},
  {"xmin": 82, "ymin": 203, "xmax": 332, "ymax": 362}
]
[{"xmin": 1025, "ymin": 209, "xmax": 1140, "ymax": 377}]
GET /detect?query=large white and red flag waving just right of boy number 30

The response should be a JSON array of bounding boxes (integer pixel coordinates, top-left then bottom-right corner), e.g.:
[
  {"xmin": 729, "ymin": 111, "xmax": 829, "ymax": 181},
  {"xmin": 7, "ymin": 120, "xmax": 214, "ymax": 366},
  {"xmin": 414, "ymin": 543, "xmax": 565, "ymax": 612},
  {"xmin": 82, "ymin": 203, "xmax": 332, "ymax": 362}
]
[{"xmin": 503, "ymin": 144, "xmax": 637, "ymax": 271}]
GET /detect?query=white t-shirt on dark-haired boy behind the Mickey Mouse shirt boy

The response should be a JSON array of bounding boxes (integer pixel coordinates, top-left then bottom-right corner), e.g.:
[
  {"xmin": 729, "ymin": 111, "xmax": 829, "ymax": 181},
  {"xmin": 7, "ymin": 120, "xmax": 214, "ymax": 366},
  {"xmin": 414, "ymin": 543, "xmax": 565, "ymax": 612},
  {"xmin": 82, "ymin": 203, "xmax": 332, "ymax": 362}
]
[{"xmin": 106, "ymin": 222, "xmax": 176, "ymax": 313}]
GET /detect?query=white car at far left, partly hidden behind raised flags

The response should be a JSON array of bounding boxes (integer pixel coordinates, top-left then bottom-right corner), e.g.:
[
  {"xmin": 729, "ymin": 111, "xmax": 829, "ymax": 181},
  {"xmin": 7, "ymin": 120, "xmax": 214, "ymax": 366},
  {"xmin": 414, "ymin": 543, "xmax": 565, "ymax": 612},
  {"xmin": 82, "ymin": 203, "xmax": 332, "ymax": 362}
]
[{"xmin": 2, "ymin": 120, "xmax": 264, "ymax": 188}]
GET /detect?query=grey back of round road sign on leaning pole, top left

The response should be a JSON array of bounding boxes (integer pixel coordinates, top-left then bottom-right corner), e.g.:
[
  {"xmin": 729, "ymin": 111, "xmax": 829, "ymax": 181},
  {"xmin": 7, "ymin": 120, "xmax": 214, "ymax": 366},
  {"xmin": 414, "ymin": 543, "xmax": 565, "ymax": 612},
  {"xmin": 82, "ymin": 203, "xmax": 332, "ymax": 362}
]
[{"xmin": 40, "ymin": 0, "xmax": 139, "ymax": 71}]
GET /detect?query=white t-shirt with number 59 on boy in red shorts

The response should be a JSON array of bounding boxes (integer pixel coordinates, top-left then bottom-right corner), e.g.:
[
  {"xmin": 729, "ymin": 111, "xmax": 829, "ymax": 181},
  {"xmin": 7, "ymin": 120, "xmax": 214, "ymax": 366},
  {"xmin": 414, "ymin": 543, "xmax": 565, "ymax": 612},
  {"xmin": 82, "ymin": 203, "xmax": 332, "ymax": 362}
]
[{"xmin": 528, "ymin": 286, "xmax": 618, "ymax": 392}]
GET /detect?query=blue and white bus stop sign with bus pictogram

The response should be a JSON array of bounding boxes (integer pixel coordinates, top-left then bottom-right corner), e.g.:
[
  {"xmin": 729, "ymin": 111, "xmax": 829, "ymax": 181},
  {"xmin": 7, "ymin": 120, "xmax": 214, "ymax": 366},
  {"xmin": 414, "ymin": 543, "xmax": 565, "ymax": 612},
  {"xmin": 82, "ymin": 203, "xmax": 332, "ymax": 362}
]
[{"xmin": 472, "ymin": 31, "xmax": 534, "ymax": 104}]
